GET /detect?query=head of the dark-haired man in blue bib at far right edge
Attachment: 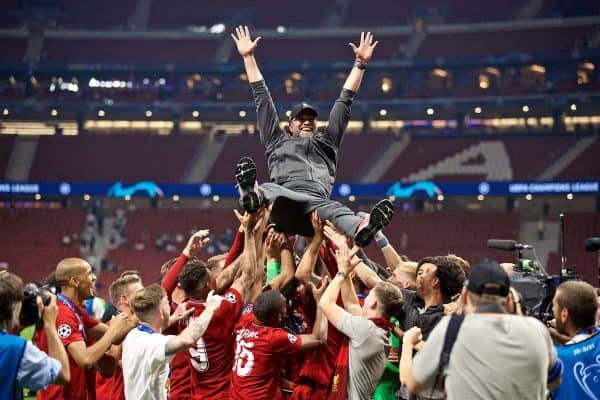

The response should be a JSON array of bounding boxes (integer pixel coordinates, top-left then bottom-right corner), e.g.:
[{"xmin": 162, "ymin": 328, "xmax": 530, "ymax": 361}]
[{"xmin": 556, "ymin": 281, "xmax": 598, "ymax": 329}]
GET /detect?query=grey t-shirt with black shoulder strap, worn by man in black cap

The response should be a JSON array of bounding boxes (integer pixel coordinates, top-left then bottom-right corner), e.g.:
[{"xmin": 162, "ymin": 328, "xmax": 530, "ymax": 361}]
[{"xmin": 413, "ymin": 314, "xmax": 556, "ymax": 400}]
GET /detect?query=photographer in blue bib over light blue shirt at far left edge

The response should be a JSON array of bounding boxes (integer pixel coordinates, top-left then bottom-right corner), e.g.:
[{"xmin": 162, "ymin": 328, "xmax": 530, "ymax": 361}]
[{"xmin": 0, "ymin": 271, "xmax": 70, "ymax": 399}]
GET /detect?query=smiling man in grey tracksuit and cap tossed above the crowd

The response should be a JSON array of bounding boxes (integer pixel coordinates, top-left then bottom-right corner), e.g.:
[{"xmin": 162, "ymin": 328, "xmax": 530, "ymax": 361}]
[{"xmin": 231, "ymin": 26, "xmax": 394, "ymax": 246}]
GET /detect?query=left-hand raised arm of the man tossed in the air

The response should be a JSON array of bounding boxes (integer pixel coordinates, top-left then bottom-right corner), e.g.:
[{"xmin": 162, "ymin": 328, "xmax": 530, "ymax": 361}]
[{"xmin": 231, "ymin": 25, "xmax": 281, "ymax": 147}]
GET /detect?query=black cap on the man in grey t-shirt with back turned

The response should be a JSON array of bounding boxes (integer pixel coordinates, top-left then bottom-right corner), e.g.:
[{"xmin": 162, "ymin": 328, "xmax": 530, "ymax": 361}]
[{"xmin": 467, "ymin": 260, "xmax": 510, "ymax": 297}]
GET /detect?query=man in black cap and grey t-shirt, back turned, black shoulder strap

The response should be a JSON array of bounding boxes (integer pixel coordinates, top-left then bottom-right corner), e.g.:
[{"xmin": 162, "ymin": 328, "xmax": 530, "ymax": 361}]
[{"xmin": 400, "ymin": 261, "xmax": 562, "ymax": 400}]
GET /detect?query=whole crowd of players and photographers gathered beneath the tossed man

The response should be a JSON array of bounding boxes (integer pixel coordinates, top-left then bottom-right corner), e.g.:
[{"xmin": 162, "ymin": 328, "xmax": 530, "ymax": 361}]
[{"xmin": 0, "ymin": 203, "xmax": 600, "ymax": 400}]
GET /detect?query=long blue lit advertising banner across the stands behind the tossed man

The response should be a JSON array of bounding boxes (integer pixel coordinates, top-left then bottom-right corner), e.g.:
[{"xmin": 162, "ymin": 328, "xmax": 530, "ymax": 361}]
[{"xmin": 0, "ymin": 181, "xmax": 600, "ymax": 199}]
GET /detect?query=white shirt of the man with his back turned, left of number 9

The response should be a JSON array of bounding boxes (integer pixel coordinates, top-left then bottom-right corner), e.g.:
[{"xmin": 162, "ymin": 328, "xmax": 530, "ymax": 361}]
[{"xmin": 122, "ymin": 328, "xmax": 173, "ymax": 400}]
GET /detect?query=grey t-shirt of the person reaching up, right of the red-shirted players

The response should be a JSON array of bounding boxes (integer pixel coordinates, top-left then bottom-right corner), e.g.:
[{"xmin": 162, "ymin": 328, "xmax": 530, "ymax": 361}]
[{"xmin": 339, "ymin": 312, "xmax": 391, "ymax": 400}]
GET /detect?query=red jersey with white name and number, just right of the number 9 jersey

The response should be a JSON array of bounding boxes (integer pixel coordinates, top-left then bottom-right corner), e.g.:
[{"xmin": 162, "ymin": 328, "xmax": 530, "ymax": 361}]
[{"xmin": 229, "ymin": 314, "xmax": 302, "ymax": 400}]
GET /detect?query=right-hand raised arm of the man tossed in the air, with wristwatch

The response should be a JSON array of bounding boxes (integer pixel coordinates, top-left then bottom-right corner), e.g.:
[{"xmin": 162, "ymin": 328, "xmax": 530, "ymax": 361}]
[{"xmin": 326, "ymin": 32, "xmax": 378, "ymax": 146}]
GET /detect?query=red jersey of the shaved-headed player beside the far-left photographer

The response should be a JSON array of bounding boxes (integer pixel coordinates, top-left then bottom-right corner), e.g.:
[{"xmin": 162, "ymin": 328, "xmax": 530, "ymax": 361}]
[{"xmin": 34, "ymin": 300, "xmax": 99, "ymax": 400}]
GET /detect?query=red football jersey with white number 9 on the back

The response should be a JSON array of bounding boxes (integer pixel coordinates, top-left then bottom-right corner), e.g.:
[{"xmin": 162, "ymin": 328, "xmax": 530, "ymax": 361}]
[{"xmin": 180, "ymin": 289, "xmax": 243, "ymax": 400}]
